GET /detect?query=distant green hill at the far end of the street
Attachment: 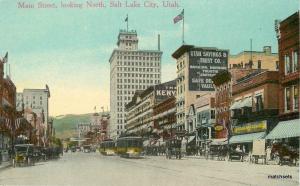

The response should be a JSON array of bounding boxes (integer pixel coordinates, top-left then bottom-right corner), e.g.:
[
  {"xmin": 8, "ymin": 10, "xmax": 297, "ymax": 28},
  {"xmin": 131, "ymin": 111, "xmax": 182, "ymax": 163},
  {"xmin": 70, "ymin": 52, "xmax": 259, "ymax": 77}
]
[{"xmin": 53, "ymin": 113, "xmax": 92, "ymax": 138}]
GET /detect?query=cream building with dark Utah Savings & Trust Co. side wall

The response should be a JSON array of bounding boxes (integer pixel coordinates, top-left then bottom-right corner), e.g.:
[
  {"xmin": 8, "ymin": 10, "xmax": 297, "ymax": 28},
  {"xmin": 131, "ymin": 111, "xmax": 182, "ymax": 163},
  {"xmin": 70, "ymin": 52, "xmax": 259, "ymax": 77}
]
[{"xmin": 172, "ymin": 45, "xmax": 228, "ymax": 132}]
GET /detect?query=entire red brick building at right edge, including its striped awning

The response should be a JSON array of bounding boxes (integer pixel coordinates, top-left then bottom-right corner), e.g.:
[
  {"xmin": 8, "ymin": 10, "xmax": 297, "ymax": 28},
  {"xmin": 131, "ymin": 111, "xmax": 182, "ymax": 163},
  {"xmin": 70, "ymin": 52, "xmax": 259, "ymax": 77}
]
[{"xmin": 266, "ymin": 11, "xmax": 300, "ymax": 147}]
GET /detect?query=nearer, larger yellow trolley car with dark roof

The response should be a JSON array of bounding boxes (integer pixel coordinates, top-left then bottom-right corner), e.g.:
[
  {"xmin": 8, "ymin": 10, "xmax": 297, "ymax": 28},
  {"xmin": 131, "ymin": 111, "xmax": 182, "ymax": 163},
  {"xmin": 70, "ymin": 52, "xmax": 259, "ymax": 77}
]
[{"xmin": 117, "ymin": 137, "xmax": 143, "ymax": 158}]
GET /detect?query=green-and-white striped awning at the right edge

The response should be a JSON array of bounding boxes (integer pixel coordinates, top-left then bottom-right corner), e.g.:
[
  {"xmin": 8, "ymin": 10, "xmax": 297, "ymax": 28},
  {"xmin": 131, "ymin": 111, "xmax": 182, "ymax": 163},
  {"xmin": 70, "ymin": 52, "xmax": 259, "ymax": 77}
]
[{"xmin": 266, "ymin": 119, "xmax": 300, "ymax": 139}]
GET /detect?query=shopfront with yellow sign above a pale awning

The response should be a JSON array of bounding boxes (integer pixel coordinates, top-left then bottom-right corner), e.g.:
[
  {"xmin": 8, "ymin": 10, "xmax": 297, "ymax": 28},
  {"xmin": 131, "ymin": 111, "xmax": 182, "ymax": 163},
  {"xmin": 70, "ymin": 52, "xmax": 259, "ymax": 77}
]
[{"xmin": 229, "ymin": 120, "xmax": 267, "ymax": 153}]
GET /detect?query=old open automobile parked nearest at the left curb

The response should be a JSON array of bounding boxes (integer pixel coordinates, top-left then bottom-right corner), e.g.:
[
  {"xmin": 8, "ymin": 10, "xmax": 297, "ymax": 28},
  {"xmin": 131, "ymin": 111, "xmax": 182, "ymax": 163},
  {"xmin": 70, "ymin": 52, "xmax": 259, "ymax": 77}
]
[{"xmin": 12, "ymin": 144, "xmax": 34, "ymax": 167}]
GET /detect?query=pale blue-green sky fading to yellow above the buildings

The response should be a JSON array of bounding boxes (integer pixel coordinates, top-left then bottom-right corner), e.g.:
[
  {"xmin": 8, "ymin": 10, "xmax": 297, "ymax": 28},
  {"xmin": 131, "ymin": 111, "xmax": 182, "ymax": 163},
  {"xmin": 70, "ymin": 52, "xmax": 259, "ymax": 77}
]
[{"xmin": 0, "ymin": 0, "xmax": 299, "ymax": 116}]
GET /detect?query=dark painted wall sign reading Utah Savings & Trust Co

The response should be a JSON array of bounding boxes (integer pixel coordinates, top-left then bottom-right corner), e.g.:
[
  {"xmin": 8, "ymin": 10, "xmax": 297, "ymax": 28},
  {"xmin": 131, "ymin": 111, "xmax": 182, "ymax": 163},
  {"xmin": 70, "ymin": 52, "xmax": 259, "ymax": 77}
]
[{"xmin": 189, "ymin": 48, "xmax": 228, "ymax": 91}]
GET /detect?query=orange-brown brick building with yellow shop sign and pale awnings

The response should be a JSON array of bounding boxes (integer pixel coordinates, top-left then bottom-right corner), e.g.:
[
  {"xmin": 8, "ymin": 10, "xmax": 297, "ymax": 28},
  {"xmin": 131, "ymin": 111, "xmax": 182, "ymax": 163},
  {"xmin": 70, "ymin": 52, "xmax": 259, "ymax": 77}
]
[{"xmin": 229, "ymin": 70, "xmax": 279, "ymax": 152}]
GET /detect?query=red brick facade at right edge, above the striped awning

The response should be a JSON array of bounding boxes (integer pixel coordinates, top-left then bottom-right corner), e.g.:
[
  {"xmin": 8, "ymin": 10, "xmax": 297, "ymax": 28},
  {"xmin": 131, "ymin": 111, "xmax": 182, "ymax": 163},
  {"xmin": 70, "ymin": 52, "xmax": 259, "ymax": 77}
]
[{"xmin": 278, "ymin": 11, "xmax": 300, "ymax": 120}]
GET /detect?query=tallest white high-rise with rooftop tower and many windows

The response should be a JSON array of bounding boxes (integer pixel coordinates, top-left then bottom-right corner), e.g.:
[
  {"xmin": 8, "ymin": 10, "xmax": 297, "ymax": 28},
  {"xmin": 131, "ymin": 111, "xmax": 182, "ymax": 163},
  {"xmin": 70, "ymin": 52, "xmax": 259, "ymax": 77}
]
[{"xmin": 109, "ymin": 30, "xmax": 162, "ymax": 138}]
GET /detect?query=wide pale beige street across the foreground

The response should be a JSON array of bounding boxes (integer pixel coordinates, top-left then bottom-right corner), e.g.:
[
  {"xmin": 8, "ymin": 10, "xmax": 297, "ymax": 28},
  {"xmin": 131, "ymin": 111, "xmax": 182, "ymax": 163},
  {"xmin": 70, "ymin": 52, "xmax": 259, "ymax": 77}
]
[{"xmin": 0, "ymin": 152, "xmax": 299, "ymax": 186}]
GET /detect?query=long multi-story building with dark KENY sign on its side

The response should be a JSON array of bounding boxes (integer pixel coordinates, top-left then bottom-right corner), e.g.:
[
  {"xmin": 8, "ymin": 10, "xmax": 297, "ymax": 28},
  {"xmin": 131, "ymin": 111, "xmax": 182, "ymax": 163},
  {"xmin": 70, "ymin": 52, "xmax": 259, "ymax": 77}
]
[{"xmin": 126, "ymin": 80, "xmax": 176, "ymax": 135}]
